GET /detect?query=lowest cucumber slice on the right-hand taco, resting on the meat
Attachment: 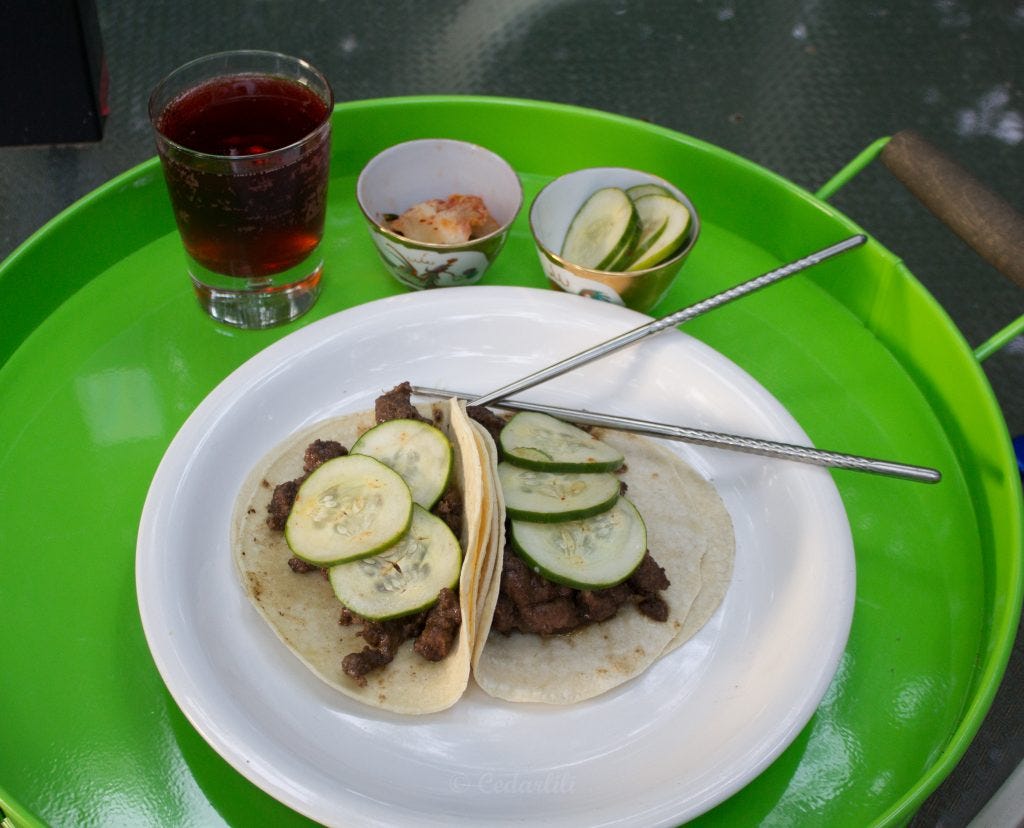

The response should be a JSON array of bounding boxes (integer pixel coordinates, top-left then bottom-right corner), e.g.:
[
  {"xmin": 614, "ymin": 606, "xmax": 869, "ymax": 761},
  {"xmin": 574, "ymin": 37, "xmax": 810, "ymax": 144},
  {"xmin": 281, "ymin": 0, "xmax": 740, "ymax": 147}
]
[{"xmin": 512, "ymin": 497, "xmax": 647, "ymax": 590}]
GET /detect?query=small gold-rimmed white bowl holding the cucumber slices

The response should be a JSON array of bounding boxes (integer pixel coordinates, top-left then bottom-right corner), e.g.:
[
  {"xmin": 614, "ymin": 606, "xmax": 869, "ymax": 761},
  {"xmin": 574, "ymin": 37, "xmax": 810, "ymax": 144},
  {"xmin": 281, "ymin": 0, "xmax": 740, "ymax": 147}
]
[{"xmin": 529, "ymin": 167, "xmax": 700, "ymax": 312}]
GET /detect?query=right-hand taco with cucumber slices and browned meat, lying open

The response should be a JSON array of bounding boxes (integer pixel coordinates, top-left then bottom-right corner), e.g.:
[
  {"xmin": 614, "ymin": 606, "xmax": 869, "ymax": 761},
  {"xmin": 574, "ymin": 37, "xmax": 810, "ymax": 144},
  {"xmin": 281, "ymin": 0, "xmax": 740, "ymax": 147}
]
[{"xmin": 469, "ymin": 407, "xmax": 735, "ymax": 704}]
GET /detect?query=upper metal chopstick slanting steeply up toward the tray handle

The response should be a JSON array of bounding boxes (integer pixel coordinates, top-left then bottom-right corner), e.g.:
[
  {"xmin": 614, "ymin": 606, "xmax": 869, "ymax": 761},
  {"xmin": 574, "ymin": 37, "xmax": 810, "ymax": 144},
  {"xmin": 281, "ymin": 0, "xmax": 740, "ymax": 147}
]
[{"xmin": 470, "ymin": 234, "xmax": 867, "ymax": 405}]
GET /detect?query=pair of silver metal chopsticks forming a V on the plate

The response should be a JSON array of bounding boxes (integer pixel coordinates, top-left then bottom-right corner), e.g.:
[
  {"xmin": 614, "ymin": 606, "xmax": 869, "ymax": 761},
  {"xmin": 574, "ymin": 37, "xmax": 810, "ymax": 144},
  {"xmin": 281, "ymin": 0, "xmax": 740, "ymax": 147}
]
[{"xmin": 413, "ymin": 234, "xmax": 942, "ymax": 483}]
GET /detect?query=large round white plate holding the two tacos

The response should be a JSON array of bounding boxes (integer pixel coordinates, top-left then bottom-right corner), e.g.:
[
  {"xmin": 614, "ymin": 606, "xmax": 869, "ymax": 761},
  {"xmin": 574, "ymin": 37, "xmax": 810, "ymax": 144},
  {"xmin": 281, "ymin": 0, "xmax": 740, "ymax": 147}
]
[{"xmin": 136, "ymin": 287, "xmax": 855, "ymax": 826}]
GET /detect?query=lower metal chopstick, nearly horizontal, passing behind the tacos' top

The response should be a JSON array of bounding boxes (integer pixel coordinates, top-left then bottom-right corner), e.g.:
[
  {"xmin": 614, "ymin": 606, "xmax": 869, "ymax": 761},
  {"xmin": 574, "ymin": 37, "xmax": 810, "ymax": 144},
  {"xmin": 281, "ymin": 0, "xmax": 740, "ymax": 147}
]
[{"xmin": 413, "ymin": 386, "xmax": 942, "ymax": 483}]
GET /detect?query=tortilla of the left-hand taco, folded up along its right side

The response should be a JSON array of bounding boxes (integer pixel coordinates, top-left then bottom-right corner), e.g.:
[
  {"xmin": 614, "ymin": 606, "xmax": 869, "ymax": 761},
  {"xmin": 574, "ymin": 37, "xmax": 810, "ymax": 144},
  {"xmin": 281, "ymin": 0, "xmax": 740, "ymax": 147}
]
[{"xmin": 231, "ymin": 400, "xmax": 495, "ymax": 713}]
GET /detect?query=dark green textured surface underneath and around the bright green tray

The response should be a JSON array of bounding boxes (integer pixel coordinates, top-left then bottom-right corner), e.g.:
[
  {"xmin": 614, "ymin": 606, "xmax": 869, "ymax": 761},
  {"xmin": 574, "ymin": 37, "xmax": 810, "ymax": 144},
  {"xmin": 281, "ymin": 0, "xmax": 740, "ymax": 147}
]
[{"xmin": 0, "ymin": 0, "xmax": 1024, "ymax": 826}]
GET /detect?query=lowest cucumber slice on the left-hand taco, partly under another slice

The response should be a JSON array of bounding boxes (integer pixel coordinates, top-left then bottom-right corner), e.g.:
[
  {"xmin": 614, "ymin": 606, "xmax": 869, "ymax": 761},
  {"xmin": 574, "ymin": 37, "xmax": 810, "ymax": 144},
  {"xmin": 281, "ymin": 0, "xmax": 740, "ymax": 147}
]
[{"xmin": 328, "ymin": 506, "xmax": 462, "ymax": 621}]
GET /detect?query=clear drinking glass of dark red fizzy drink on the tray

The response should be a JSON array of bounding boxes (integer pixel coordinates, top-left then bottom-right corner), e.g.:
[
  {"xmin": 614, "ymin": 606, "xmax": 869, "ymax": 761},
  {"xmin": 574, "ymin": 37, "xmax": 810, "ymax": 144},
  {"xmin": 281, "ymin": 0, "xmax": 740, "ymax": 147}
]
[{"xmin": 150, "ymin": 50, "xmax": 334, "ymax": 329}]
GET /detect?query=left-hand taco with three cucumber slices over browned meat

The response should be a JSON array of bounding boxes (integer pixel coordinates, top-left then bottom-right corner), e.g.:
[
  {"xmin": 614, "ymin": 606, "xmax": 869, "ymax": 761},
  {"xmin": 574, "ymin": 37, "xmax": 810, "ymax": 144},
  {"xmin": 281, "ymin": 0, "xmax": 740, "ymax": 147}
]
[{"xmin": 231, "ymin": 383, "xmax": 498, "ymax": 713}]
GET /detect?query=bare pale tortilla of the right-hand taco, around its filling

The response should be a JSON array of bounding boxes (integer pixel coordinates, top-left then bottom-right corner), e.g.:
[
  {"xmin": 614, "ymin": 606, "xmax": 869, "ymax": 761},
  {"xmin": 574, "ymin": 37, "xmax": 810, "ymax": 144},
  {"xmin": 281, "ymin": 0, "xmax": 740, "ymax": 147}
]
[{"xmin": 473, "ymin": 430, "xmax": 735, "ymax": 704}]
